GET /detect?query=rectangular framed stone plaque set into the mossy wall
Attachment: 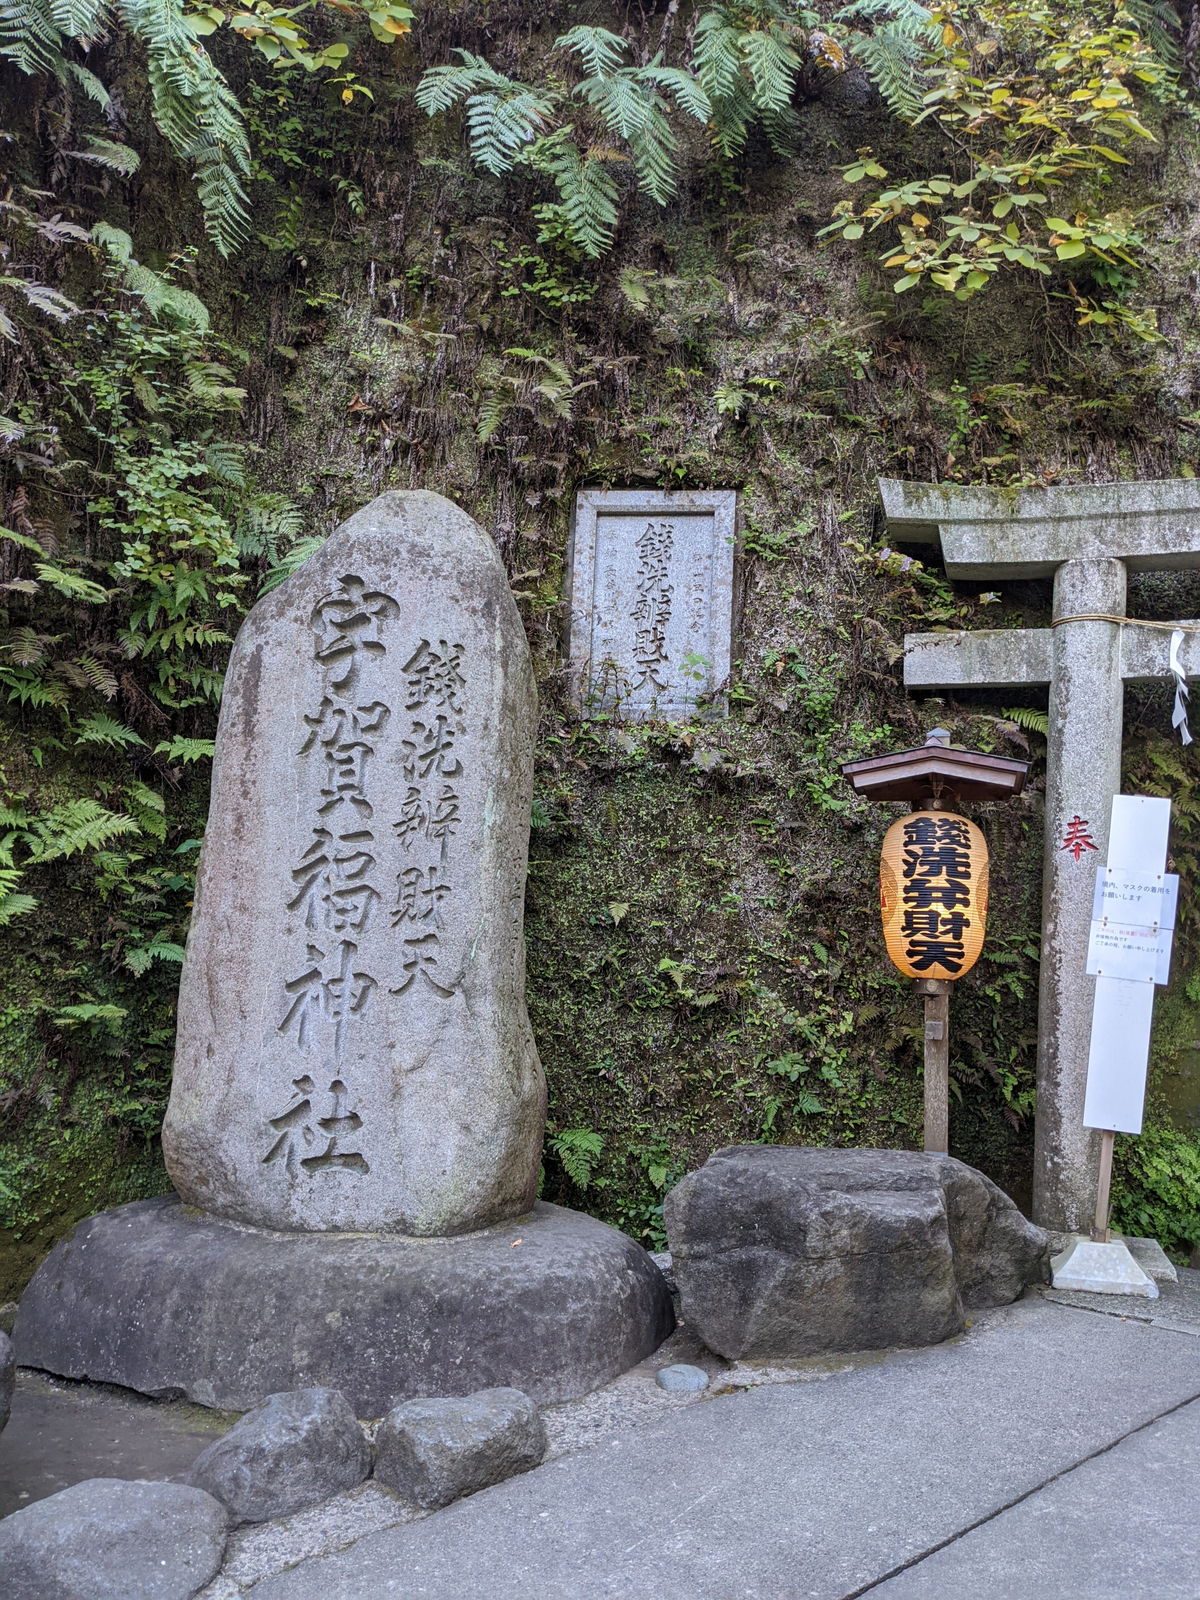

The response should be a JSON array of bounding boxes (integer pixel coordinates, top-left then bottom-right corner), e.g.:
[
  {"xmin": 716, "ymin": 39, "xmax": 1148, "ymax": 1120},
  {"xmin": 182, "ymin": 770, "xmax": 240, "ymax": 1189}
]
[{"xmin": 570, "ymin": 490, "xmax": 738, "ymax": 718}]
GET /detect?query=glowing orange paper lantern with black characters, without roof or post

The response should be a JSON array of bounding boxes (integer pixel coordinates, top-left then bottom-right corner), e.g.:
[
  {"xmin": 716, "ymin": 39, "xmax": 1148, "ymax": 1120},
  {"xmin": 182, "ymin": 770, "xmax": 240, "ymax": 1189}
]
[{"xmin": 878, "ymin": 811, "xmax": 987, "ymax": 978}]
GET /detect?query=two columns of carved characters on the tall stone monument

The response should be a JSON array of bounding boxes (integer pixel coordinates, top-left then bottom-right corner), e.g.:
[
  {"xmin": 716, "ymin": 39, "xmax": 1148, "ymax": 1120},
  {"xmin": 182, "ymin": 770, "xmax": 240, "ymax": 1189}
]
[{"xmin": 262, "ymin": 574, "xmax": 466, "ymax": 1178}]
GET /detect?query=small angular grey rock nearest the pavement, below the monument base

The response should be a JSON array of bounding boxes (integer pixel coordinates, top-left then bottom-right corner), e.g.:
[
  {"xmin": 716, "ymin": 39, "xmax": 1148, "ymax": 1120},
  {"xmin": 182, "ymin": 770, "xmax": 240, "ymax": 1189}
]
[{"xmin": 374, "ymin": 1389, "xmax": 546, "ymax": 1510}]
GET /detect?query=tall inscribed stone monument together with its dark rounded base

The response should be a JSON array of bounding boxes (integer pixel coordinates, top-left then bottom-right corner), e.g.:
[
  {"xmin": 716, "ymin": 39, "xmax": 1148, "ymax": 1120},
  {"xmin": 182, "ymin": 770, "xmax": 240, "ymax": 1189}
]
[{"xmin": 16, "ymin": 491, "xmax": 670, "ymax": 1414}]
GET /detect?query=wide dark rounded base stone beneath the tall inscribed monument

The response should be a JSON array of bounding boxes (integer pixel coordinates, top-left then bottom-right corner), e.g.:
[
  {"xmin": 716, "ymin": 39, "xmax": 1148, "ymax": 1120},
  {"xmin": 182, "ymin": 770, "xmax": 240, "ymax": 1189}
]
[{"xmin": 14, "ymin": 1195, "xmax": 674, "ymax": 1418}]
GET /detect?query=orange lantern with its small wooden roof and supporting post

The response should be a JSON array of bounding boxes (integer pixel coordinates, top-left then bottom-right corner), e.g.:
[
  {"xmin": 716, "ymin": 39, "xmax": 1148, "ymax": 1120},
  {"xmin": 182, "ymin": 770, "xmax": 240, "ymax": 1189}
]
[{"xmin": 842, "ymin": 728, "xmax": 1029, "ymax": 1155}]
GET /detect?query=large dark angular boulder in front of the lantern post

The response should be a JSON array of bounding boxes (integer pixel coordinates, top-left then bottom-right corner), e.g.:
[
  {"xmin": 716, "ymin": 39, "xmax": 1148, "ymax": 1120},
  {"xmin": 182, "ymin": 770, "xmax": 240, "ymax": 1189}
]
[{"xmin": 664, "ymin": 1146, "xmax": 1050, "ymax": 1360}]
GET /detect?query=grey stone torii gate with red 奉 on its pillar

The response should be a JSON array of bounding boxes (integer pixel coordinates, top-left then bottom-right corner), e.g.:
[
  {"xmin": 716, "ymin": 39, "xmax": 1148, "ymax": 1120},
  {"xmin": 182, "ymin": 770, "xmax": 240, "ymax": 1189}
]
[{"xmin": 880, "ymin": 478, "xmax": 1200, "ymax": 1232}]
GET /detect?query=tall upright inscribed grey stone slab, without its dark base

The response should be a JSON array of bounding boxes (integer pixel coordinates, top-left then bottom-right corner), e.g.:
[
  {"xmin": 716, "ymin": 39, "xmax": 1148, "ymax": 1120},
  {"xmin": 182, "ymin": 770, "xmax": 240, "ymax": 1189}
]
[{"xmin": 163, "ymin": 491, "xmax": 544, "ymax": 1235}]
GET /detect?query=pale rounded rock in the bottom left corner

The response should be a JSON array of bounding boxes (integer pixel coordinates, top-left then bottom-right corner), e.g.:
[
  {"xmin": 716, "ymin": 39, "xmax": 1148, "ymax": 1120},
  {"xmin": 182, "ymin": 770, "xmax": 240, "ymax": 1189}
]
[{"xmin": 0, "ymin": 1478, "xmax": 229, "ymax": 1600}]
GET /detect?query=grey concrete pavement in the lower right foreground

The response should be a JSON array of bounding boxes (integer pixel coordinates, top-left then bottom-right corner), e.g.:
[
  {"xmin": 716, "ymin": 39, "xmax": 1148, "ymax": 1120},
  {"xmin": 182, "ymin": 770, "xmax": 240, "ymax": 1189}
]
[{"xmin": 248, "ymin": 1298, "xmax": 1200, "ymax": 1600}]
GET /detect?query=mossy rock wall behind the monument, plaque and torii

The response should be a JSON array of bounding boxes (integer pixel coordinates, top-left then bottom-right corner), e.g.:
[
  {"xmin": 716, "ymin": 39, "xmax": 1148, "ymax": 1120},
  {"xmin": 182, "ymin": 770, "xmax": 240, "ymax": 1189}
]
[{"xmin": 0, "ymin": 11, "xmax": 1200, "ymax": 1299}]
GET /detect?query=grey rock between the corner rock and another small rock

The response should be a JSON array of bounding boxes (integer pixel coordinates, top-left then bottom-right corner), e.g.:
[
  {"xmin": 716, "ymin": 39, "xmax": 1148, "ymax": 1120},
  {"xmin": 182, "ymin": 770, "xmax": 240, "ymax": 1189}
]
[{"xmin": 181, "ymin": 1389, "xmax": 371, "ymax": 1522}]
